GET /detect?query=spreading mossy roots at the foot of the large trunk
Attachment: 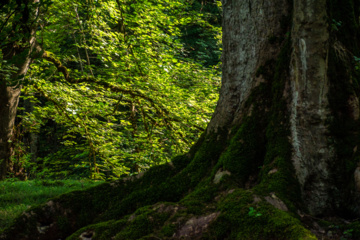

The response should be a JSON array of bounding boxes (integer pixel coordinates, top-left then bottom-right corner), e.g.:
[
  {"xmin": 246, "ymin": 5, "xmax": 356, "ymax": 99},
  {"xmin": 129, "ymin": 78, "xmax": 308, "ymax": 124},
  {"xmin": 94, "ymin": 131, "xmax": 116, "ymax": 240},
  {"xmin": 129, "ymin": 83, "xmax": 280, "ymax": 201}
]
[{"xmin": 0, "ymin": 141, "xmax": 360, "ymax": 240}]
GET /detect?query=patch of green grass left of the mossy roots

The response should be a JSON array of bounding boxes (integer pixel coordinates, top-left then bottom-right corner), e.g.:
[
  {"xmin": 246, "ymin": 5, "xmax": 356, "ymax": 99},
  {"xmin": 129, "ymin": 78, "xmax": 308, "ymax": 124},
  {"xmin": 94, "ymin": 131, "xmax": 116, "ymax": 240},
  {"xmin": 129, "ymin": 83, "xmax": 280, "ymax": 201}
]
[{"xmin": 0, "ymin": 179, "xmax": 101, "ymax": 232}]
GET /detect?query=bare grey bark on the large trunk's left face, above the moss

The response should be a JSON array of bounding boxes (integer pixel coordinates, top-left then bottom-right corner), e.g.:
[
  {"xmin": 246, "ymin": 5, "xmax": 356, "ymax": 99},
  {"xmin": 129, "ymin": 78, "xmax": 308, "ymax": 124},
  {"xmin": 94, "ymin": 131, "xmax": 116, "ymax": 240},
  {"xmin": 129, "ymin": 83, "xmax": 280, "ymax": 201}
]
[{"xmin": 207, "ymin": 0, "xmax": 290, "ymax": 132}]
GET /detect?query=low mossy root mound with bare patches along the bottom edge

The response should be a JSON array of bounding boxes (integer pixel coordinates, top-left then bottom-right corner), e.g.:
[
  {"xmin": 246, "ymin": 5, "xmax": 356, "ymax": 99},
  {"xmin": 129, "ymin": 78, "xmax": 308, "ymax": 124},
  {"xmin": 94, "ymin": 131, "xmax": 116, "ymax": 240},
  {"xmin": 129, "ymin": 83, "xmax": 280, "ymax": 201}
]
[{"xmin": 67, "ymin": 189, "xmax": 316, "ymax": 240}]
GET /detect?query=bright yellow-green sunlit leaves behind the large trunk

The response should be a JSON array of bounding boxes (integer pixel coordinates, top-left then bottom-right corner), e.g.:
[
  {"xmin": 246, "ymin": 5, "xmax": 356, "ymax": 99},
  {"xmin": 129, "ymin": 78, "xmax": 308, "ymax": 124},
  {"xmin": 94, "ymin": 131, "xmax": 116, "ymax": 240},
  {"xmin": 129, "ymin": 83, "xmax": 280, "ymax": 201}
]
[{"xmin": 16, "ymin": 0, "xmax": 221, "ymax": 178}]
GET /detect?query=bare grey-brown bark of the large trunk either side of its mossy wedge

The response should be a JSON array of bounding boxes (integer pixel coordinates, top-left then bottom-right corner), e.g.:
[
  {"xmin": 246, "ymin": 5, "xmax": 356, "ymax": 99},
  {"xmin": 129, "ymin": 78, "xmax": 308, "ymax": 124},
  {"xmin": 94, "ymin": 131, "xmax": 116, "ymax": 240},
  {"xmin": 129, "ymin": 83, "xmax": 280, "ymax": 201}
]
[{"xmin": 211, "ymin": 0, "xmax": 360, "ymax": 215}]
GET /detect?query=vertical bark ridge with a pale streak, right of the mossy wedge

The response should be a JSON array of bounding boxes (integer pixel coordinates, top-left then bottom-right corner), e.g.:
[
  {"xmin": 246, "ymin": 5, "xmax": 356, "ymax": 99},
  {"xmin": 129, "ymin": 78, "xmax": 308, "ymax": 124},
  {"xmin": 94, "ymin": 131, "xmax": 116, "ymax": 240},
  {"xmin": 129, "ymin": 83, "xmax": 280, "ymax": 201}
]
[{"xmin": 290, "ymin": 0, "xmax": 335, "ymax": 214}]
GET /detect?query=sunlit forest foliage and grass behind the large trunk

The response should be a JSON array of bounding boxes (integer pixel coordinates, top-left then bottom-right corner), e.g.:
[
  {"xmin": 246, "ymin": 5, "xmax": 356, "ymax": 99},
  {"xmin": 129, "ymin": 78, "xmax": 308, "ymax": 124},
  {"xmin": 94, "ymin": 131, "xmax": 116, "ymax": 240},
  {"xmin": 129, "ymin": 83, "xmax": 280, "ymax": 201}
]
[{"xmin": 0, "ymin": 0, "xmax": 221, "ymax": 231}]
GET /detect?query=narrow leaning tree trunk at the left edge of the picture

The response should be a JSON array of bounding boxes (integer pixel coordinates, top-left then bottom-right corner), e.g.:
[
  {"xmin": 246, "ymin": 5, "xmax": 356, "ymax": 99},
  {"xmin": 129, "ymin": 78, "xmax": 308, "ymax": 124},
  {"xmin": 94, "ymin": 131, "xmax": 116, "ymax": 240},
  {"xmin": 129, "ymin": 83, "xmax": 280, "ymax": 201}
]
[{"xmin": 0, "ymin": 0, "xmax": 38, "ymax": 180}]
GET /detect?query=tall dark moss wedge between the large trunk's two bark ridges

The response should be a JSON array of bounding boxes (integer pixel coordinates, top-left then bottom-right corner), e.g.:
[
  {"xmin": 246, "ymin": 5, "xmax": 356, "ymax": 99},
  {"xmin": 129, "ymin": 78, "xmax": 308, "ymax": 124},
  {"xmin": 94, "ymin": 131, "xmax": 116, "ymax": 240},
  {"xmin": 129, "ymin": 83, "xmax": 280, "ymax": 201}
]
[{"xmin": 219, "ymin": 40, "xmax": 301, "ymax": 211}]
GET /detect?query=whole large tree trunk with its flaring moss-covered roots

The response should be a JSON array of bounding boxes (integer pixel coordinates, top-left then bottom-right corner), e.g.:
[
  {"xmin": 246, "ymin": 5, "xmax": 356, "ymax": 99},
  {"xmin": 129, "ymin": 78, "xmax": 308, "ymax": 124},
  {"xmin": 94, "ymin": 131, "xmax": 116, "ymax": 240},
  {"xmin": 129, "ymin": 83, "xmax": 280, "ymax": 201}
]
[{"xmin": 0, "ymin": 0, "xmax": 360, "ymax": 239}]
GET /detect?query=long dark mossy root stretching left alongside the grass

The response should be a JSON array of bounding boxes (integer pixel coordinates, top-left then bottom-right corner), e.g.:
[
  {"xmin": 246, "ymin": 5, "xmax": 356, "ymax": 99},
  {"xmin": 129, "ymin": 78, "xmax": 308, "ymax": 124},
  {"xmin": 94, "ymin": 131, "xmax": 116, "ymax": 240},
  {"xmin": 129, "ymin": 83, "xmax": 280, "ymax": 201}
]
[{"xmin": 0, "ymin": 158, "xmax": 194, "ymax": 238}]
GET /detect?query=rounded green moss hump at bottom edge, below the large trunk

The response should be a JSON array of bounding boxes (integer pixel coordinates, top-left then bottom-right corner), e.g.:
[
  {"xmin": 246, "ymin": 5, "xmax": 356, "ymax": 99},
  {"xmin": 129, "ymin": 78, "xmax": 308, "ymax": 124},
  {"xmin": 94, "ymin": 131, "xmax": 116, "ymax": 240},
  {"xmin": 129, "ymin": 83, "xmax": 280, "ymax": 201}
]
[{"xmin": 208, "ymin": 189, "xmax": 316, "ymax": 239}]
